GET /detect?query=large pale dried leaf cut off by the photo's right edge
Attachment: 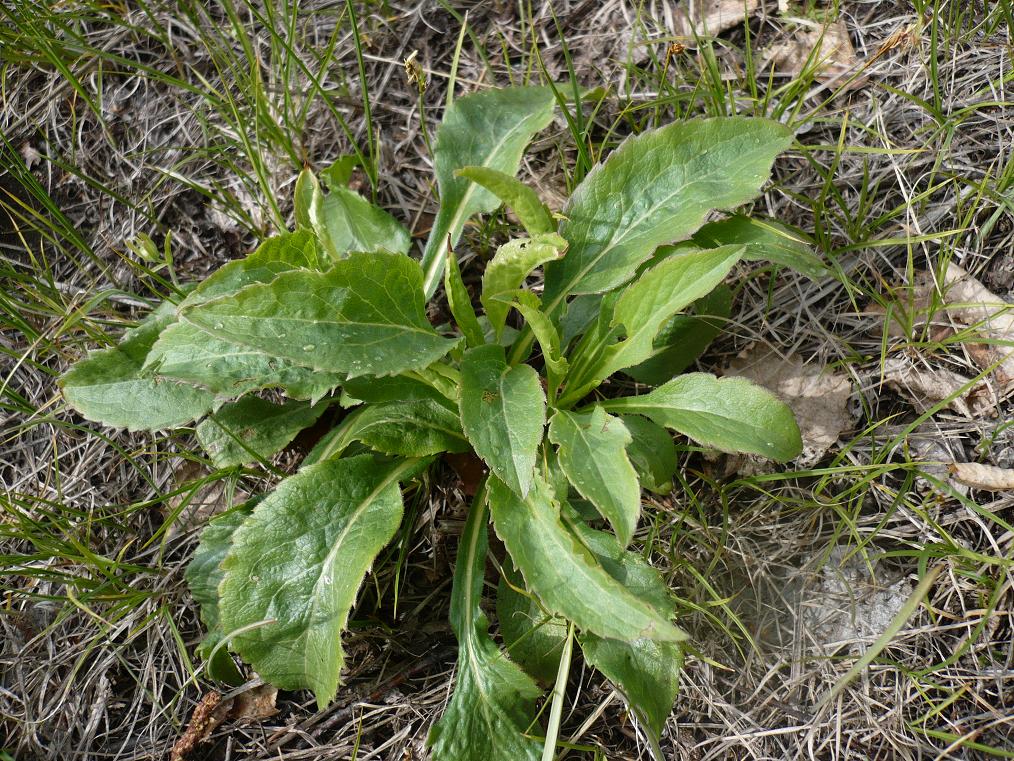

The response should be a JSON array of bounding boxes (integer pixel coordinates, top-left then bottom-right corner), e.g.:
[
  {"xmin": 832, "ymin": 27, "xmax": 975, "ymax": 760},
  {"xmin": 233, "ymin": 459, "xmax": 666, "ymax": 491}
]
[{"xmin": 944, "ymin": 264, "xmax": 1014, "ymax": 392}]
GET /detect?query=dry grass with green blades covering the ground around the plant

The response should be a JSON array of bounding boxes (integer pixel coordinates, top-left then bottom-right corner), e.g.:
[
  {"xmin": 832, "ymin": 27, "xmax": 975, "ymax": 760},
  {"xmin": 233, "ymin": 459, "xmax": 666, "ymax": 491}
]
[{"xmin": 0, "ymin": 0, "xmax": 1014, "ymax": 761}]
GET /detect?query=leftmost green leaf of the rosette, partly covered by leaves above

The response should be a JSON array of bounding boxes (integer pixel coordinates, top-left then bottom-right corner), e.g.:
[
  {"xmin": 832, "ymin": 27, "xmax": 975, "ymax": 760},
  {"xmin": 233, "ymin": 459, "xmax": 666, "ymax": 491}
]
[{"xmin": 59, "ymin": 302, "xmax": 215, "ymax": 430}]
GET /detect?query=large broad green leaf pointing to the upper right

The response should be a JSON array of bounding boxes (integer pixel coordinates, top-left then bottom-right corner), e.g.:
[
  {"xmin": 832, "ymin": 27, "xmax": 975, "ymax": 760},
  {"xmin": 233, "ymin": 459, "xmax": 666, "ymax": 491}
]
[{"xmin": 545, "ymin": 117, "xmax": 792, "ymax": 306}]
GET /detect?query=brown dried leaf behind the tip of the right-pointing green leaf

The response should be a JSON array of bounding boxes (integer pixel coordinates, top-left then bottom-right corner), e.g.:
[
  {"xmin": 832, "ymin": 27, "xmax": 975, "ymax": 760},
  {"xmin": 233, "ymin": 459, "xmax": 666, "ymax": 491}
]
[{"xmin": 725, "ymin": 350, "xmax": 853, "ymax": 468}]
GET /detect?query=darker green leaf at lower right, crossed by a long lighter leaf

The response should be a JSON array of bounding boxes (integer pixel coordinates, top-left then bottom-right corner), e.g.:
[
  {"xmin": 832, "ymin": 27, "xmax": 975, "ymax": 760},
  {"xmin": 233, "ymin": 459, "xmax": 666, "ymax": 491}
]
[{"xmin": 568, "ymin": 520, "xmax": 683, "ymax": 740}]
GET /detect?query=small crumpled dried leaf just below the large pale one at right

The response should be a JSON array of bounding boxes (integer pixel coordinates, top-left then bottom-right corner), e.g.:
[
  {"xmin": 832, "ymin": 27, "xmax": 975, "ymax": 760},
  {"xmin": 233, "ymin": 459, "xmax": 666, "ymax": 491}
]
[{"xmin": 883, "ymin": 357, "xmax": 997, "ymax": 418}]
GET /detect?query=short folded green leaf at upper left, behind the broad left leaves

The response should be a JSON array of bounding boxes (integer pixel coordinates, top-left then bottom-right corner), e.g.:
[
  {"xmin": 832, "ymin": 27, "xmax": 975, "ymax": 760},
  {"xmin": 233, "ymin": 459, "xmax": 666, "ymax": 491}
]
[{"xmin": 295, "ymin": 169, "xmax": 412, "ymax": 261}]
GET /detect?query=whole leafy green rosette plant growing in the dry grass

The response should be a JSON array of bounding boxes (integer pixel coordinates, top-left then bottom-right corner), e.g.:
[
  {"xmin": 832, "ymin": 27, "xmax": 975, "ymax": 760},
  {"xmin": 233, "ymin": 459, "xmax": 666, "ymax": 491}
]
[{"xmin": 61, "ymin": 87, "xmax": 822, "ymax": 761}]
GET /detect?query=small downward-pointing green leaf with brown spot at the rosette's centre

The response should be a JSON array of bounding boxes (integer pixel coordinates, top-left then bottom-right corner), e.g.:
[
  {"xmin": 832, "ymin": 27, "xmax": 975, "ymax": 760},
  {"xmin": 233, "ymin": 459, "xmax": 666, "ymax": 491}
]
[{"xmin": 459, "ymin": 345, "xmax": 546, "ymax": 496}]
